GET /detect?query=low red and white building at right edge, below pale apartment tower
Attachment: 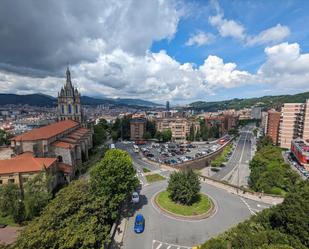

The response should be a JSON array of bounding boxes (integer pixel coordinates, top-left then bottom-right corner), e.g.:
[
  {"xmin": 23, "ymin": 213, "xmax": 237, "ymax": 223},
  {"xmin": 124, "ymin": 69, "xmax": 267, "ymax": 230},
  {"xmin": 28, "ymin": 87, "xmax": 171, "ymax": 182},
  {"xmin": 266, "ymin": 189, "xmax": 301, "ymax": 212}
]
[{"xmin": 291, "ymin": 138, "xmax": 309, "ymax": 171}]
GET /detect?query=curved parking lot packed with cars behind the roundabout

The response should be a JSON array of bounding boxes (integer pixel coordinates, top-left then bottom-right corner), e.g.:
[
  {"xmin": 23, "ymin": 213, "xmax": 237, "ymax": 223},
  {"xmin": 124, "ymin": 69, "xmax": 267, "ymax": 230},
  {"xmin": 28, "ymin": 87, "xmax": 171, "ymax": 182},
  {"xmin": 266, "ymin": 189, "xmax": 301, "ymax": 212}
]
[{"xmin": 140, "ymin": 136, "xmax": 230, "ymax": 165}]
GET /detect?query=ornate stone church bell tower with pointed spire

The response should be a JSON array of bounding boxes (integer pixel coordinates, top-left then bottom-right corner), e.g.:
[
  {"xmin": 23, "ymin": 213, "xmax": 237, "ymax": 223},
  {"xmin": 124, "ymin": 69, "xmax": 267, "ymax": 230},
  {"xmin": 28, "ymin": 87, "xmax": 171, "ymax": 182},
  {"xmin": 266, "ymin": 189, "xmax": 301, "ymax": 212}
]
[{"xmin": 58, "ymin": 67, "xmax": 83, "ymax": 123}]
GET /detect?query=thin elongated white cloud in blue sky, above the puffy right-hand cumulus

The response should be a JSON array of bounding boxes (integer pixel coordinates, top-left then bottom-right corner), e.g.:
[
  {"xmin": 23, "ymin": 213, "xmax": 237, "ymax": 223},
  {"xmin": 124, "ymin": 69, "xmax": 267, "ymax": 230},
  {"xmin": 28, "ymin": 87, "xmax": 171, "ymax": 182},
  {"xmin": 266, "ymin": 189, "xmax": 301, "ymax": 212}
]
[{"xmin": 247, "ymin": 24, "xmax": 291, "ymax": 46}]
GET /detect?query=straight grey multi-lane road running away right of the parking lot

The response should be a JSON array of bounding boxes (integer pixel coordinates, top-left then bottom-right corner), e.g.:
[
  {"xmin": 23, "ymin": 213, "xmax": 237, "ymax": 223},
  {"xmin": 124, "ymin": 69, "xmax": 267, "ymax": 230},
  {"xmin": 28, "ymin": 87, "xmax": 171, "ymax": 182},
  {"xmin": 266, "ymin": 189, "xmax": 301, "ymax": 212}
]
[{"xmin": 212, "ymin": 127, "xmax": 254, "ymax": 186}]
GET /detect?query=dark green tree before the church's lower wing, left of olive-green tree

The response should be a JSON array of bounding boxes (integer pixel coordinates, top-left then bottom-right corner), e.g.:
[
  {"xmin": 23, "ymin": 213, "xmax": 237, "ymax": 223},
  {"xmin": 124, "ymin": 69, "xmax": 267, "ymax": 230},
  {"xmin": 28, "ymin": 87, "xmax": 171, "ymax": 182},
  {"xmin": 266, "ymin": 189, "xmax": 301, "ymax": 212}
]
[{"xmin": 24, "ymin": 173, "xmax": 52, "ymax": 220}]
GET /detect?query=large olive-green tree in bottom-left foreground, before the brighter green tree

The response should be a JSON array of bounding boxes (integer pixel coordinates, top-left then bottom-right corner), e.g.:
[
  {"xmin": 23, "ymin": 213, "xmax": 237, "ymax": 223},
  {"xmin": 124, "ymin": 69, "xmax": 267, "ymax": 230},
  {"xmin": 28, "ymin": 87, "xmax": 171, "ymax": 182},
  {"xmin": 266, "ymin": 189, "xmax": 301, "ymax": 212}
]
[{"xmin": 14, "ymin": 180, "xmax": 112, "ymax": 249}]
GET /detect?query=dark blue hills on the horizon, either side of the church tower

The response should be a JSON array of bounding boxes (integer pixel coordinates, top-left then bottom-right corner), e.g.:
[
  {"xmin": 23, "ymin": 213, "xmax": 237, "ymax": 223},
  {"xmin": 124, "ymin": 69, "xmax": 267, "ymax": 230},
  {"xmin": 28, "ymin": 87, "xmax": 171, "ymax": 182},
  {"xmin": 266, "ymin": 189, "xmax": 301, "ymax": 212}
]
[{"xmin": 0, "ymin": 94, "xmax": 161, "ymax": 107}]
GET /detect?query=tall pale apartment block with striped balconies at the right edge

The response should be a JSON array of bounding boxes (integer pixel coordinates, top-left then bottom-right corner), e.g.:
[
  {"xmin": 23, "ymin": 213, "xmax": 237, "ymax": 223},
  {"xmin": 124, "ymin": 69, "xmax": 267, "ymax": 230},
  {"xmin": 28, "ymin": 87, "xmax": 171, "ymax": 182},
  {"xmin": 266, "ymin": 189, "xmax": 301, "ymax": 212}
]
[{"xmin": 279, "ymin": 100, "xmax": 309, "ymax": 149}]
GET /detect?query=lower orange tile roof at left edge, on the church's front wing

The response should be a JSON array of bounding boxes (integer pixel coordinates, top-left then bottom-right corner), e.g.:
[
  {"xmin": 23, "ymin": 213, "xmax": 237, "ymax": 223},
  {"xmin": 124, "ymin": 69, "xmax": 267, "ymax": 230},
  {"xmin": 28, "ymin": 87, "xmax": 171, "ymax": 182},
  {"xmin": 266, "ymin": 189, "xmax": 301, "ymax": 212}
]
[{"xmin": 0, "ymin": 153, "xmax": 57, "ymax": 174}]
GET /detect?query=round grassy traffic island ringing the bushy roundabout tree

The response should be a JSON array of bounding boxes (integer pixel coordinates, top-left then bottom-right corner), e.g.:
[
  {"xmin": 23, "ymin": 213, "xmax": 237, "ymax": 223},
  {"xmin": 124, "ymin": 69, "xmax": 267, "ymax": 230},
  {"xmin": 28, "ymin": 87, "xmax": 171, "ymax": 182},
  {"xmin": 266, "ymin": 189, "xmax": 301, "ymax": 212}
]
[{"xmin": 154, "ymin": 190, "xmax": 215, "ymax": 220}]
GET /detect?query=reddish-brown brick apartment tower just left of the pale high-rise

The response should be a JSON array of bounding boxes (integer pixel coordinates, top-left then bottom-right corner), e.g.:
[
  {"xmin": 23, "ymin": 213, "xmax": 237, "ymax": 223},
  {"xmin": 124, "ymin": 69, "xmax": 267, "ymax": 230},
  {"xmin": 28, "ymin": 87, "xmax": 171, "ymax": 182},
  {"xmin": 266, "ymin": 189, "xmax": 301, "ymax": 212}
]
[{"xmin": 265, "ymin": 110, "xmax": 281, "ymax": 144}]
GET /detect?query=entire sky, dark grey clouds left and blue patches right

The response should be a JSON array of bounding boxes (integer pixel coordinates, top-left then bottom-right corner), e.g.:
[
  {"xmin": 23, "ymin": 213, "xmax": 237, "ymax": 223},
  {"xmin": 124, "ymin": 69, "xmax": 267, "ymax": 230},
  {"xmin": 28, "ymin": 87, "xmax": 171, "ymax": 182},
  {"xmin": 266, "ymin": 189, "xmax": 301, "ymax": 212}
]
[{"xmin": 0, "ymin": 0, "xmax": 309, "ymax": 104}]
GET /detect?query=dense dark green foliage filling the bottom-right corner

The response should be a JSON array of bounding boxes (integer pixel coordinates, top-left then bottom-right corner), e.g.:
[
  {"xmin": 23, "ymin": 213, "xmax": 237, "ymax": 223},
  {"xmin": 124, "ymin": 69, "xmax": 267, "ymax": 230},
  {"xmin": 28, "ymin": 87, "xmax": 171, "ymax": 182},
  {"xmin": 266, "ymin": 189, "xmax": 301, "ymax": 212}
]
[{"xmin": 201, "ymin": 182, "xmax": 309, "ymax": 249}]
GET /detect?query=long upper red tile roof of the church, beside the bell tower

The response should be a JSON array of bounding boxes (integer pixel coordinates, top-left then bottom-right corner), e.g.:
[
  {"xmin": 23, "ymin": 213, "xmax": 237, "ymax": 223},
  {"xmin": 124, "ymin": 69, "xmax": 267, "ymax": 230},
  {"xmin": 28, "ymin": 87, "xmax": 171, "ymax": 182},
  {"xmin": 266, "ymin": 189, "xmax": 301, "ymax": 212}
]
[{"xmin": 12, "ymin": 120, "xmax": 79, "ymax": 141}]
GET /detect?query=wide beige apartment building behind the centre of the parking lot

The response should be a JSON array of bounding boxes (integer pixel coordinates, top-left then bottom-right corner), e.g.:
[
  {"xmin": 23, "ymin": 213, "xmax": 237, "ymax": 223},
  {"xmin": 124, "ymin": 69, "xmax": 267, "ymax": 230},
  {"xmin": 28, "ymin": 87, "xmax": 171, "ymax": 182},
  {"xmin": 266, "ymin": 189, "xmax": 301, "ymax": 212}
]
[{"xmin": 156, "ymin": 118, "xmax": 200, "ymax": 142}]
